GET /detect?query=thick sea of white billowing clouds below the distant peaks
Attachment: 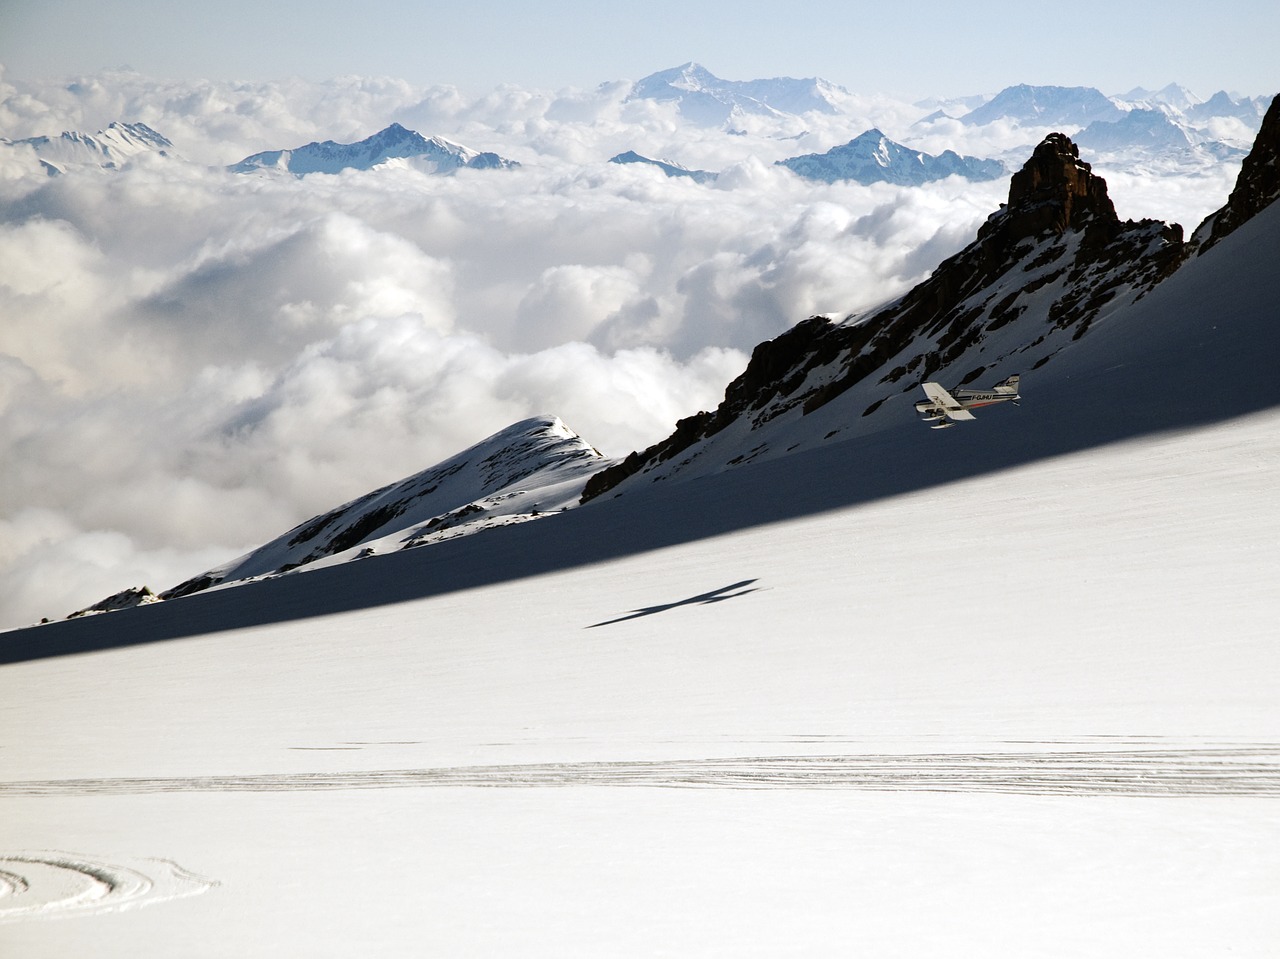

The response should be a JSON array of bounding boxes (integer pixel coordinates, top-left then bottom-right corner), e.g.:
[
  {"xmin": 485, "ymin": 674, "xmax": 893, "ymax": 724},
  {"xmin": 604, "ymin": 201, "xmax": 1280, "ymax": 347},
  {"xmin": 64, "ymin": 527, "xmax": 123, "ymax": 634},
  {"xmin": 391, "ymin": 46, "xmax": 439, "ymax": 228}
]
[{"xmin": 0, "ymin": 65, "xmax": 1238, "ymax": 627}]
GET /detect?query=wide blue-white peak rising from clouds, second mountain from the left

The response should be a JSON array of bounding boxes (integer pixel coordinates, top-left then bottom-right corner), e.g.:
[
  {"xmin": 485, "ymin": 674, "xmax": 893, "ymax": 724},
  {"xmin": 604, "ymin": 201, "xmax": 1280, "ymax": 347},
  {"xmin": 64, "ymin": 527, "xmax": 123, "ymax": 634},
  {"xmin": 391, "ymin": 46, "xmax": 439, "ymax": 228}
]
[{"xmin": 227, "ymin": 123, "xmax": 520, "ymax": 177}]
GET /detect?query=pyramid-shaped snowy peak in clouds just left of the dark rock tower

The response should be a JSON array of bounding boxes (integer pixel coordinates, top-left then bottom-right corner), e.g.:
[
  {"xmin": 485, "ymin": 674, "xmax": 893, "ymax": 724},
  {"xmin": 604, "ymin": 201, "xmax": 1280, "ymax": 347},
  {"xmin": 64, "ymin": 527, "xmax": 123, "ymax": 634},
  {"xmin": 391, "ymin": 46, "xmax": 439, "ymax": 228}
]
[{"xmin": 777, "ymin": 129, "xmax": 1005, "ymax": 187}]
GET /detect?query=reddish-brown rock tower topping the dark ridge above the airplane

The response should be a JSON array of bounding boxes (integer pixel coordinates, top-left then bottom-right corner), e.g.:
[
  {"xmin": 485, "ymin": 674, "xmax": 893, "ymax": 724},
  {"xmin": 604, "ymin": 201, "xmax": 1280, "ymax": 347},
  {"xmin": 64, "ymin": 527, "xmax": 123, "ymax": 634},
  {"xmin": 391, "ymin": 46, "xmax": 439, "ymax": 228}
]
[{"xmin": 978, "ymin": 133, "xmax": 1120, "ymax": 245}]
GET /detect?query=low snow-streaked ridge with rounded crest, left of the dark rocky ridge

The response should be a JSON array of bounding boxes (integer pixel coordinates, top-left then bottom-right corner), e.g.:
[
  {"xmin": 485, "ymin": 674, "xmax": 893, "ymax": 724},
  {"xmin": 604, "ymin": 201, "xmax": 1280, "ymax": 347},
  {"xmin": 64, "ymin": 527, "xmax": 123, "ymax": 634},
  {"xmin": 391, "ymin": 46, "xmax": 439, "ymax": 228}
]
[{"xmin": 161, "ymin": 416, "xmax": 608, "ymax": 599}]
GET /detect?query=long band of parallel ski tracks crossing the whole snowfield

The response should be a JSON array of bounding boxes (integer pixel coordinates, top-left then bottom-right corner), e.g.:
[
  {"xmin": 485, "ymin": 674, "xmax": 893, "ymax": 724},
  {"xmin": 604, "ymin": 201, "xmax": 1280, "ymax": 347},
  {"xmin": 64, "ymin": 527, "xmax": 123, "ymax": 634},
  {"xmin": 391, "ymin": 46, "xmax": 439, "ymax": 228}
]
[{"xmin": 0, "ymin": 744, "xmax": 1280, "ymax": 798}]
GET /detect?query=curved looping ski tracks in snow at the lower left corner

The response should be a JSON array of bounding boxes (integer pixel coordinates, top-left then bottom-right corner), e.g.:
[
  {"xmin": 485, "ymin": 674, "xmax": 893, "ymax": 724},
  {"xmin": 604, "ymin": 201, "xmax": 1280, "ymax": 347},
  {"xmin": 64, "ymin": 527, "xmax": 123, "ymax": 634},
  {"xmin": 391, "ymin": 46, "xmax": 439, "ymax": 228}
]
[{"xmin": 0, "ymin": 851, "xmax": 218, "ymax": 923}]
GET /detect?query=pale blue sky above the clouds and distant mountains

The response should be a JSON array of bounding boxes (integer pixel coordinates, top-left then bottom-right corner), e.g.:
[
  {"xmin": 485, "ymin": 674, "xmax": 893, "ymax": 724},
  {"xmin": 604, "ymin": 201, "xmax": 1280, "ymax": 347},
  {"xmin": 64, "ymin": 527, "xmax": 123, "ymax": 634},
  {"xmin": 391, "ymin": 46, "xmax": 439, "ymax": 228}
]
[{"xmin": 0, "ymin": 0, "xmax": 1280, "ymax": 96}]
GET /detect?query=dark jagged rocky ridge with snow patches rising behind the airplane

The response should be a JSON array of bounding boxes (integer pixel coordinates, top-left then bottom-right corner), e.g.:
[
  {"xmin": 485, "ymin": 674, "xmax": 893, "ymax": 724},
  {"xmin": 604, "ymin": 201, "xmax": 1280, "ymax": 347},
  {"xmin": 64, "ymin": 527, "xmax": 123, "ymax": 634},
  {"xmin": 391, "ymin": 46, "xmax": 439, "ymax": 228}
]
[{"xmin": 582, "ymin": 133, "xmax": 1184, "ymax": 502}]
